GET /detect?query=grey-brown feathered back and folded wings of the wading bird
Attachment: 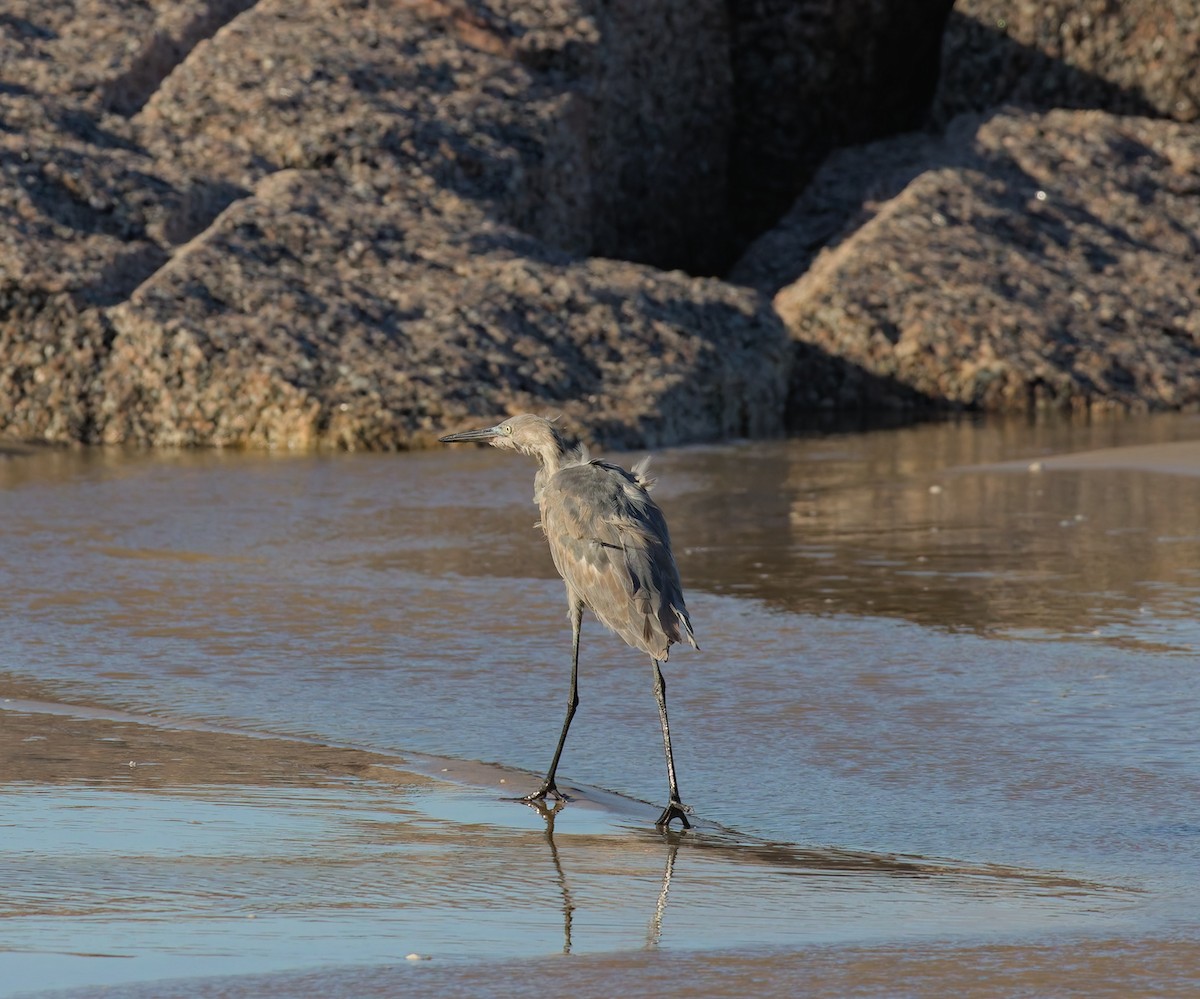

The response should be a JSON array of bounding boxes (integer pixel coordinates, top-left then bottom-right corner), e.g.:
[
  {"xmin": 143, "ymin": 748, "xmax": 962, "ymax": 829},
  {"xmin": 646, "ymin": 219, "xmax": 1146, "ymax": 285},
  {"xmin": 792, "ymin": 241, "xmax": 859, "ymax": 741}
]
[{"xmin": 539, "ymin": 461, "xmax": 696, "ymax": 659}]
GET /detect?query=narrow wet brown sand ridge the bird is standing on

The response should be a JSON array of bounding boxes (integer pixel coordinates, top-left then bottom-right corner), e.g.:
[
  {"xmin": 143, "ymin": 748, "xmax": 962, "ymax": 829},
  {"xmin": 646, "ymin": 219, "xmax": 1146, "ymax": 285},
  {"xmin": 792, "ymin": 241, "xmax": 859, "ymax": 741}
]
[{"xmin": 0, "ymin": 674, "xmax": 1123, "ymax": 892}]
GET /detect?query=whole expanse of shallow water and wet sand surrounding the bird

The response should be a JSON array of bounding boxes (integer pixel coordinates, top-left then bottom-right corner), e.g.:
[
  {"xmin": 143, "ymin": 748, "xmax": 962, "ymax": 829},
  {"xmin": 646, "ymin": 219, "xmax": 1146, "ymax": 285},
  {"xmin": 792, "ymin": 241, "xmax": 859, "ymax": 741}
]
[{"xmin": 0, "ymin": 417, "xmax": 1200, "ymax": 995}]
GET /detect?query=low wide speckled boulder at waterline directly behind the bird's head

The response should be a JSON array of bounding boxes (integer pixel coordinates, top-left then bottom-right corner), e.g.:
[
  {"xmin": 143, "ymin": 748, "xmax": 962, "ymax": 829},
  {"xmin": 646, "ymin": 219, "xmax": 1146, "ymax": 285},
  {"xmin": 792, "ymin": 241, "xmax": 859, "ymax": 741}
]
[{"xmin": 100, "ymin": 171, "xmax": 787, "ymax": 448}]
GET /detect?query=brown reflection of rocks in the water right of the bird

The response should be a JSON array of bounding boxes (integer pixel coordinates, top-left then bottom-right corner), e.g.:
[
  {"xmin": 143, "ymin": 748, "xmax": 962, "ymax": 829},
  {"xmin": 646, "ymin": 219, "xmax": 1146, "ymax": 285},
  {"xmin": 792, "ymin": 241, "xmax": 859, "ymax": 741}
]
[{"xmin": 660, "ymin": 421, "xmax": 1200, "ymax": 632}]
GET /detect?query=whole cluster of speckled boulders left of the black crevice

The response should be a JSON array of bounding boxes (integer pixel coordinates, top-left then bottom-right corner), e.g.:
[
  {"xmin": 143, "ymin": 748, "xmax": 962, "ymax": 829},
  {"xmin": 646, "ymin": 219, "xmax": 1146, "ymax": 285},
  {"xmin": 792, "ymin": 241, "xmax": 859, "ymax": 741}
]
[{"xmin": 0, "ymin": 0, "xmax": 790, "ymax": 447}]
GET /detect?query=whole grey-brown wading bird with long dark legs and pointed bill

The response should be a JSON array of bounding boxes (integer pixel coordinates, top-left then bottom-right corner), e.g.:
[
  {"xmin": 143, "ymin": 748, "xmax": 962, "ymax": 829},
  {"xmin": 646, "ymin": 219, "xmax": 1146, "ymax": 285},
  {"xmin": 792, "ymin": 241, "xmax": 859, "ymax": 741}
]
[{"xmin": 439, "ymin": 415, "xmax": 700, "ymax": 828}]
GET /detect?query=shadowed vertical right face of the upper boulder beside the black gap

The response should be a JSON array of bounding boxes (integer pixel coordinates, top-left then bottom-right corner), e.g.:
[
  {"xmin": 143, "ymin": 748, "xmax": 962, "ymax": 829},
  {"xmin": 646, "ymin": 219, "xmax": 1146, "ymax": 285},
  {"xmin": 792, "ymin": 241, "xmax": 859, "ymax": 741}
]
[{"xmin": 573, "ymin": 0, "xmax": 736, "ymax": 274}]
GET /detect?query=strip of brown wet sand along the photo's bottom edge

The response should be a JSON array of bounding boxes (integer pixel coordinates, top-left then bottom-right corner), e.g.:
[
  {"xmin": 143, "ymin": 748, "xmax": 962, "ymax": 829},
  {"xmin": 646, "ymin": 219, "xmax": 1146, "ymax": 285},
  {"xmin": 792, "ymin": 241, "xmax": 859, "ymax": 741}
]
[{"xmin": 44, "ymin": 938, "xmax": 1200, "ymax": 999}]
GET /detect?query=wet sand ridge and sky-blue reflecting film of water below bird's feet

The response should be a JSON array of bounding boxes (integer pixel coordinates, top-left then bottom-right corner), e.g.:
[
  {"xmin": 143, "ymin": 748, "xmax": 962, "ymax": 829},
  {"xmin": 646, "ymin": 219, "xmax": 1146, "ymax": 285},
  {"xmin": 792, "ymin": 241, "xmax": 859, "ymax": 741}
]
[{"xmin": 0, "ymin": 690, "xmax": 1138, "ymax": 995}]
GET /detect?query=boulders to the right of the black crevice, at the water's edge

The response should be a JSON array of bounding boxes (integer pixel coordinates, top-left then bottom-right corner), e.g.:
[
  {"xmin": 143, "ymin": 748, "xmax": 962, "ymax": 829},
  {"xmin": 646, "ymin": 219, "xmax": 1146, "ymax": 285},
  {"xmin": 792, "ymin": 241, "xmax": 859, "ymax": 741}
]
[{"xmin": 731, "ymin": 0, "xmax": 1200, "ymax": 411}]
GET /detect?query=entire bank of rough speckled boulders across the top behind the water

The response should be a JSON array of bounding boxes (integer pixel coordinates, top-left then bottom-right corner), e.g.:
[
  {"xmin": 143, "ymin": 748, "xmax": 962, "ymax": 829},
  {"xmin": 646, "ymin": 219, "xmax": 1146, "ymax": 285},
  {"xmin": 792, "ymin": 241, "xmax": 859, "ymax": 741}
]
[{"xmin": 0, "ymin": 0, "xmax": 1200, "ymax": 447}]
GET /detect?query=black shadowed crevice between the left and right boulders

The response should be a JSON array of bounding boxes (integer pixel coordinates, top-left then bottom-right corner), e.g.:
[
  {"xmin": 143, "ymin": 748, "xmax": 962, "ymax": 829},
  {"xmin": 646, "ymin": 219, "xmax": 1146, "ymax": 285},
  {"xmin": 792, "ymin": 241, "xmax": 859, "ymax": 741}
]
[{"xmin": 686, "ymin": 0, "xmax": 1164, "ymax": 284}]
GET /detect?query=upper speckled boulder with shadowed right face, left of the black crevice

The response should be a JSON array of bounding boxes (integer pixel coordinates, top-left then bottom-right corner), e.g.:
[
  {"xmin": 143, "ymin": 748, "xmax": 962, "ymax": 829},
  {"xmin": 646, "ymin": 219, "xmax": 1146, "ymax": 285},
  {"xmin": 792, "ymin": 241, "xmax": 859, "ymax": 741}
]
[{"xmin": 134, "ymin": 0, "xmax": 730, "ymax": 269}]
